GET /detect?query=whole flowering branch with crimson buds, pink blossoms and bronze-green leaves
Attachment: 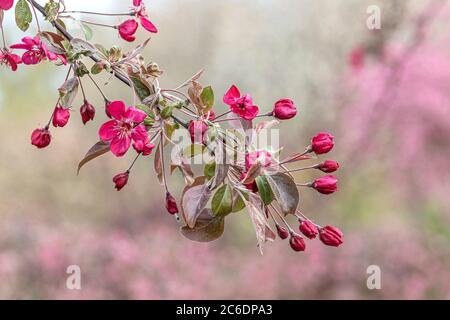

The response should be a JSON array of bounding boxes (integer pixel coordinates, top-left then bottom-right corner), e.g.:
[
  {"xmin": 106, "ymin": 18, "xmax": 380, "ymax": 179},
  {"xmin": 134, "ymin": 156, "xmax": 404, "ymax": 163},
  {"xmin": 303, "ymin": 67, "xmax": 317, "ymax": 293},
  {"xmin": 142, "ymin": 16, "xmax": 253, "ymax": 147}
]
[{"xmin": 0, "ymin": 0, "xmax": 343, "ymax": 251}]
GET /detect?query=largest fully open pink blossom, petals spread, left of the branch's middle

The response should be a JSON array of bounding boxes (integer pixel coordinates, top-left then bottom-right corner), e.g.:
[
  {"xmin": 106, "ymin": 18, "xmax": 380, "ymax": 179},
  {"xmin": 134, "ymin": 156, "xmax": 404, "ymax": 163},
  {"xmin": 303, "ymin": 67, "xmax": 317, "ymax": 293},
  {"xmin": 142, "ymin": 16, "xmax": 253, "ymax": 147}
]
[{"xmin": 98, "ymin": 101, "xmax": 148, "ymax": 157}]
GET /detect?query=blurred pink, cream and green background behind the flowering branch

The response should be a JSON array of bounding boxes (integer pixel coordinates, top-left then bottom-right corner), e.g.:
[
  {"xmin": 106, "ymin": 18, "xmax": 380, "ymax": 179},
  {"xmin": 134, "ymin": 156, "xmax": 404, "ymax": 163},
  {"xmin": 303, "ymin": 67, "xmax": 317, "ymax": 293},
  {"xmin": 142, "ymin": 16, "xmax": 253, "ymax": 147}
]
[{"xmin": 0, "ymin": 0, "xmax": 450, "ymax": 299}]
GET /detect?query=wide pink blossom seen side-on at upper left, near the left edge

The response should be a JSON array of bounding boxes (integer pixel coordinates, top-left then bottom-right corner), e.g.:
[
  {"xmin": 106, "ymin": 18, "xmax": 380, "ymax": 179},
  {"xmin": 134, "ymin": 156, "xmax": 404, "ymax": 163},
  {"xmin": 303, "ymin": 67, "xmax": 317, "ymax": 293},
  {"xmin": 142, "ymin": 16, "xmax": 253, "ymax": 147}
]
[{"xmin": 11, "ymin": 36, "xmax": 67, "ymax": 65}]
